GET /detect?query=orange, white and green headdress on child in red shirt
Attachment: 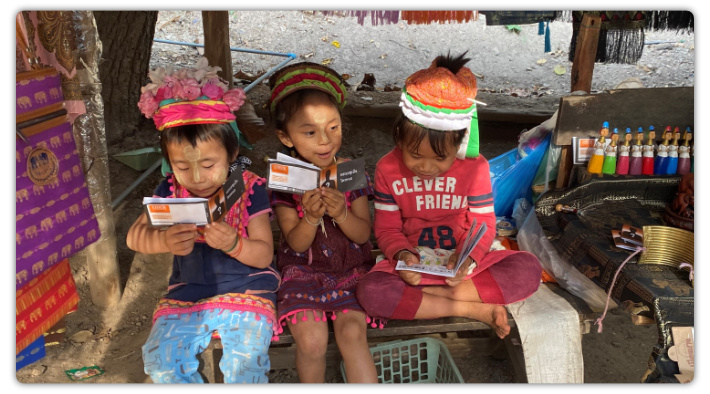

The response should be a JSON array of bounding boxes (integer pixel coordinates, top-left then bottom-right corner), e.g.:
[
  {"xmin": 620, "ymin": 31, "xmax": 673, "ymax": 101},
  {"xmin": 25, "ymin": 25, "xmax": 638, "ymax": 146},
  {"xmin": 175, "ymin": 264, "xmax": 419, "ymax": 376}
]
[{"xmin": 399, "ymin": 54, "xmax": 478, "ymax": 159}]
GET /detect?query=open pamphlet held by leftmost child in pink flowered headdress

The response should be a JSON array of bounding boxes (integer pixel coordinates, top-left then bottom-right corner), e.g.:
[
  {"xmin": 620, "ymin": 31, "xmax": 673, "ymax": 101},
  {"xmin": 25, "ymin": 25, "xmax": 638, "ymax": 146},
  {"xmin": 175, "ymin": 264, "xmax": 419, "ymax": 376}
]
[{"xmin": 143, "ymin": 164, "xmax": 244, "ymax": 227}]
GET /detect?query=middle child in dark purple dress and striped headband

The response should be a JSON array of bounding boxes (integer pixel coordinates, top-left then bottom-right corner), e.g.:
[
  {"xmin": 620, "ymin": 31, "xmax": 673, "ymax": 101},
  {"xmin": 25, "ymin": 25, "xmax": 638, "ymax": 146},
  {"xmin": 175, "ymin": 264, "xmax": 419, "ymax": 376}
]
[{"xmin": 269, "ymin": 63, "xmax": 377, "ymax": 383}]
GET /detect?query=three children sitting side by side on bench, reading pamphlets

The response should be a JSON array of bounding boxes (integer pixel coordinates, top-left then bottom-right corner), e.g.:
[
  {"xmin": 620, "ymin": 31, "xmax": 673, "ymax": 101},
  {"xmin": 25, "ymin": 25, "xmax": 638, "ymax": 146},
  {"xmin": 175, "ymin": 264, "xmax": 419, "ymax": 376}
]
[{"xmin": 128, "ymin": 54, "xmax": 542, "ymax": 383}]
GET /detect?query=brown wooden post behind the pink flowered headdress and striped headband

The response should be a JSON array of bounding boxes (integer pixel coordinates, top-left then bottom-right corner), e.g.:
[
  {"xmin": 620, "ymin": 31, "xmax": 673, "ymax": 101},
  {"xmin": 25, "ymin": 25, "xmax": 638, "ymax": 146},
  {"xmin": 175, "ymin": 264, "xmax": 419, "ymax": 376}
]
[{"xmin": 202, "ymin": 11, "xmax": 234, "ymax": 89}]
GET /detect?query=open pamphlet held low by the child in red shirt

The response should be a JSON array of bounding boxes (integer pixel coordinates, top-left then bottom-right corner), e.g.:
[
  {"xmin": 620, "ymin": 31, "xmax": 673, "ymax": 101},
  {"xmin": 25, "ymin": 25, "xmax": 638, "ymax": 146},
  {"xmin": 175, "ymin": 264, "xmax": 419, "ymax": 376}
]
[{"xmin": 395, "ymin": 220, "xmax": 488, "ymax": 278}]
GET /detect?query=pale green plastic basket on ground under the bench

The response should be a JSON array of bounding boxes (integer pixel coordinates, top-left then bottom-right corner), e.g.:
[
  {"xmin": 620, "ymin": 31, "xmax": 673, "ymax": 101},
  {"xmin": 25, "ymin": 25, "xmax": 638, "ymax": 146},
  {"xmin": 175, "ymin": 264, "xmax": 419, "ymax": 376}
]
[{"xmin": 340, "ymin": 338, "xmax": 464, "ymax": 383}]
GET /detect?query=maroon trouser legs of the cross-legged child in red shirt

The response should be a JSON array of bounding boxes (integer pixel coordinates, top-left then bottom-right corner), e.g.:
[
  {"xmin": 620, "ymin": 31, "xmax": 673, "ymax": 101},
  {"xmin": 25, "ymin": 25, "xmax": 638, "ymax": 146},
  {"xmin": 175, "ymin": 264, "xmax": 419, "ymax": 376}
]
[{"xmin": 356, "ymin": 250, "xmax": 542, "ymax": 320}]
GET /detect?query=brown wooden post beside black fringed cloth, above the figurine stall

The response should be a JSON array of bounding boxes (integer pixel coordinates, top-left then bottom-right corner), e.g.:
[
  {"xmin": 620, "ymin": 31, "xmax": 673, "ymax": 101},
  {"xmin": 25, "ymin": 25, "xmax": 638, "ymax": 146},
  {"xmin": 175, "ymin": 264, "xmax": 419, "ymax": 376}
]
[{"xmin": 571, "ymin": 14, "xmax": 601, "ymax": 93}]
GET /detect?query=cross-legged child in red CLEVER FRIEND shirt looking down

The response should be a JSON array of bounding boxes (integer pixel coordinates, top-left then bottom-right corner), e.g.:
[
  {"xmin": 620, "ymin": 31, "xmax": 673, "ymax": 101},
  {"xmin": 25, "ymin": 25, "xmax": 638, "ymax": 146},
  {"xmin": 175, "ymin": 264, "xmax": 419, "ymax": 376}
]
[{"xmin": 356, "ymin": 54, "xmax": 542, "ymax": 338}]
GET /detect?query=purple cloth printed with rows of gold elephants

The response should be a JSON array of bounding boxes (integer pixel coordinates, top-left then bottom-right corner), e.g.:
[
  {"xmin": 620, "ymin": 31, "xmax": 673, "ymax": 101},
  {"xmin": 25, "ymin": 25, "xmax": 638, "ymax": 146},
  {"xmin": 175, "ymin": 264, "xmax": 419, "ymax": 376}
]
[{"xmin": 15, "ymin": 116, "xmax": 101, "ymax": 289}]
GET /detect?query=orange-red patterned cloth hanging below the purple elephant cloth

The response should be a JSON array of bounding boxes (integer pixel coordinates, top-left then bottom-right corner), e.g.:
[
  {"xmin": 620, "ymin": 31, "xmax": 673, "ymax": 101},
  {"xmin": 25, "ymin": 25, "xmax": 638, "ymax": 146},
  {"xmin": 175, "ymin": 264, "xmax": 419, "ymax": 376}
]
[{"xmin": 15, "ymin": 260, "xmax": 79, "ymax": 355}]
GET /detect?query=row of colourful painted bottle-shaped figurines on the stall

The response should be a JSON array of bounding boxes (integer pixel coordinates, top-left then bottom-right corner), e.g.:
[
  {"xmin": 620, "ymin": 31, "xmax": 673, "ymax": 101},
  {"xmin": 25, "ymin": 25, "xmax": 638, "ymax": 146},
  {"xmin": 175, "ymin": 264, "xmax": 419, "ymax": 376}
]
[{"xmin": 587, "ymin": 122, "xmax": 693, "ymax": 175}]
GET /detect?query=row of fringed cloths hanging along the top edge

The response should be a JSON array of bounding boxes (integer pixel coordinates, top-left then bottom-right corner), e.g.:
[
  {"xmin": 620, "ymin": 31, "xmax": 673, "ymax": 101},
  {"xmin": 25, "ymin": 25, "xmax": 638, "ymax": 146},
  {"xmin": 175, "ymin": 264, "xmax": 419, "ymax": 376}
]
[{"xmin": 321, "ymin": 10, "xmax": 695, "ymax": 64}]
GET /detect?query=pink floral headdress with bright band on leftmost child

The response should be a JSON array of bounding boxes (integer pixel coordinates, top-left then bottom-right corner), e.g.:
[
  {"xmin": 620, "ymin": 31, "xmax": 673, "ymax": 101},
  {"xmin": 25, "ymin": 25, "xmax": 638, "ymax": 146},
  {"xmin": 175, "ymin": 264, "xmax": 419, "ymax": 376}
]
[{"xmin": 138, "ymin": 57, "xmax": 248, "ymax": 146}]
